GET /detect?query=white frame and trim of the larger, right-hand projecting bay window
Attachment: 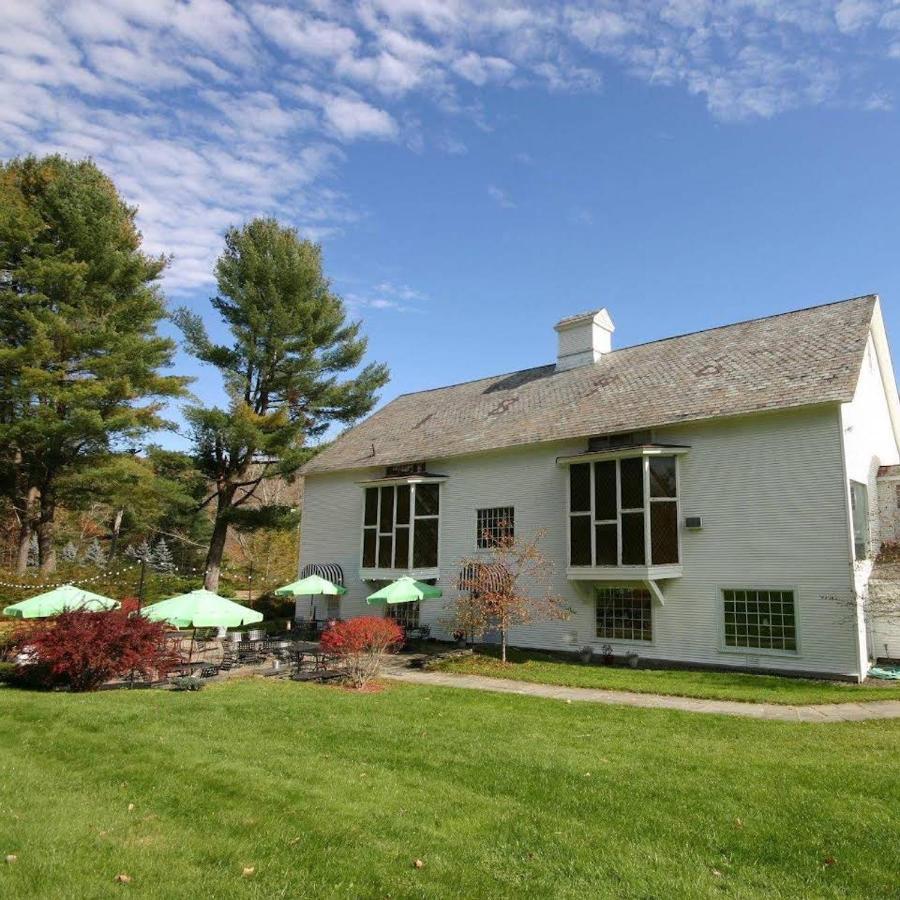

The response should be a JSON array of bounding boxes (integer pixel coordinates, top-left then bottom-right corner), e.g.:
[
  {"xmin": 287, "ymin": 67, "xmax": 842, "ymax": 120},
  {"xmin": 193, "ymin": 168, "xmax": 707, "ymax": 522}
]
[{"xmin": 557, "ymin": 447, "xmax": 687, "ymax": 579}]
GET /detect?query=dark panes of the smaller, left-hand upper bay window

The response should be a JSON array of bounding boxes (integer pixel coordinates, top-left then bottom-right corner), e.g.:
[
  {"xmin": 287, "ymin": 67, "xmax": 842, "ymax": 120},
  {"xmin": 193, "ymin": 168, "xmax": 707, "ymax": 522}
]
[{"xmin": 362, "ymin": 482, "xmax": 440, "ymax": 569}]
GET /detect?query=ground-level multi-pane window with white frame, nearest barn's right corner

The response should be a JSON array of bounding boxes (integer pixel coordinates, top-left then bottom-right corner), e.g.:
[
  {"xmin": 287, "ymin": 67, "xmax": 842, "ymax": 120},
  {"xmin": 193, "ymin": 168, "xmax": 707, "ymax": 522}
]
[{"xmin": 722, "ymin": 589, "xmax": 797, "ymax": 650}]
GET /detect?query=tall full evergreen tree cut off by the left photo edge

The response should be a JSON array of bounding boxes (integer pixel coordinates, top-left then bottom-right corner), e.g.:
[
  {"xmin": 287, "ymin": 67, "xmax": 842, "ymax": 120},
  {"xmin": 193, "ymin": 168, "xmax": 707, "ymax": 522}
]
[{"xmin": 0, "ymin": 156, "xmax": 186, "ymax": 571}]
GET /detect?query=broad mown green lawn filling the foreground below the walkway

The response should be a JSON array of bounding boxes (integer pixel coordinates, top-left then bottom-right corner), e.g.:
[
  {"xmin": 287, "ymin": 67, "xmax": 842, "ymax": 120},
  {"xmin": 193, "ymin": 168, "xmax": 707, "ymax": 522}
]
[{"xmin": 0, "ymin": 679, "xmax": 900, "ymax": 900}]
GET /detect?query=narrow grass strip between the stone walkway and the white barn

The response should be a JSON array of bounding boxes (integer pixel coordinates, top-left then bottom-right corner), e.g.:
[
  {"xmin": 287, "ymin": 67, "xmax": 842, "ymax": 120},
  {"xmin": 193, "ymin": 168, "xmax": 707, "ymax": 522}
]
[{"xmin": 433, "ymin": 650, "xmax": 900, "ymax": 704}]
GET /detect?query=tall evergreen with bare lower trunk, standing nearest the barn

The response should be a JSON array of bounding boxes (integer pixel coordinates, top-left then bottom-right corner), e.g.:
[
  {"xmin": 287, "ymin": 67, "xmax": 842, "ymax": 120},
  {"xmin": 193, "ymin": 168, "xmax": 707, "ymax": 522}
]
[{"xmin": 177, "ymin": 219, "xmax": 388, "ymax": 590}]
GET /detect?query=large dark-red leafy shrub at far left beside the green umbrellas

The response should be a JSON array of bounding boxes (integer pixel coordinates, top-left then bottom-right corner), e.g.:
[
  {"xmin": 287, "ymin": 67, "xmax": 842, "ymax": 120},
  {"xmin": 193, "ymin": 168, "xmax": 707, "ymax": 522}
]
[{"xmin": 16, "ymin": 610, "xmax": 177, "ymax": 691}]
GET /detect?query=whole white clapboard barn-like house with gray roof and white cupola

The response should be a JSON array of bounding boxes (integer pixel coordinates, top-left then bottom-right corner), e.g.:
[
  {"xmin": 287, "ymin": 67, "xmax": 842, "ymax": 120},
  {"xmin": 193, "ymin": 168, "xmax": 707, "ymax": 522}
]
[{"xmin": 298, "ymin": 296, "xmax": 900, "ymax": 678}]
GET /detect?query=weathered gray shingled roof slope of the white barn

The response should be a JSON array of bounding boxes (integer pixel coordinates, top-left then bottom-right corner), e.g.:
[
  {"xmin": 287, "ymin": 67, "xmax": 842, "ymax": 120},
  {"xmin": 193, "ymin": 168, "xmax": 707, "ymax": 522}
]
[{"xmin": 304, "ymin": 295, "xmax": 876, "ymax": 474}]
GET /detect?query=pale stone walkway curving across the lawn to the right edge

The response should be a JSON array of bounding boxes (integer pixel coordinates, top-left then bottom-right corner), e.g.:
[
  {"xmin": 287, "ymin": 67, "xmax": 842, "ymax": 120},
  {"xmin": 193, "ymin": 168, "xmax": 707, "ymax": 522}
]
[{"xmin": 384, "ymin": 667, "xmax": 900, "ymax": 722}]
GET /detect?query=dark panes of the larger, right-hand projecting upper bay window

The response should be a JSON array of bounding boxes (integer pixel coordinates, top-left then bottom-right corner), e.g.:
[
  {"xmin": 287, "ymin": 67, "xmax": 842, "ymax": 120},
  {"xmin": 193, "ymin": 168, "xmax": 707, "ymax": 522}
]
[{"xmin": 569, "ymin": 456, "xmax": 678, "ymax": 566}]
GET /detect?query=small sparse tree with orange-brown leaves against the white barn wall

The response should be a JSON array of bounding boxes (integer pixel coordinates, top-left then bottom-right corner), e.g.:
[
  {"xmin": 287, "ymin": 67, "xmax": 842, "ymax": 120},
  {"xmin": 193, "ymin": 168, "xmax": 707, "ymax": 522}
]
[{"xmin": 447, "ymin": 528, "xmax": 572, "ymax": 662}]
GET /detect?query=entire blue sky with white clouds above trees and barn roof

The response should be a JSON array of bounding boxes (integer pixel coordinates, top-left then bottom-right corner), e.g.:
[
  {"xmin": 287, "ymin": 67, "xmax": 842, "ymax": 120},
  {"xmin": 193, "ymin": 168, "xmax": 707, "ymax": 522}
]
[{"xmin": 0, "ymin": 0, "xmax": 900, "ymax": 443}]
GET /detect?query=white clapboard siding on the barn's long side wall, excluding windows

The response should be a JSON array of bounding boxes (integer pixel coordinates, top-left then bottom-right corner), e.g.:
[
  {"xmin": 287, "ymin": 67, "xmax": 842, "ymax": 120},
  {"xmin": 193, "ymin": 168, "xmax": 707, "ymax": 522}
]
[{"xmin": 301, "ymin": 405, "xmax": 872, "ymax": 675}]
